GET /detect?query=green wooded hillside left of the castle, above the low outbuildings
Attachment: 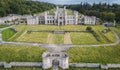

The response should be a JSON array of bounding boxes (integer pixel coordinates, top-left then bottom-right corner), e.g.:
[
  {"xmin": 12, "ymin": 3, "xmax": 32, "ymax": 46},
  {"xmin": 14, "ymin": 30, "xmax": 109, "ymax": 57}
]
[{"xmin": 0, "ymin": 0, "xmax": 55, "ymax": 17}]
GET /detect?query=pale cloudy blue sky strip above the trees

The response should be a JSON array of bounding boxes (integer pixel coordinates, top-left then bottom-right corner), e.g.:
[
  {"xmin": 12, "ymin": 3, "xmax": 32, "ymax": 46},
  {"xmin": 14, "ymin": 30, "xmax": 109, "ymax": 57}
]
[{"xmin": 35, "ymin": 0, "xmax": 120, "ymax": 4}]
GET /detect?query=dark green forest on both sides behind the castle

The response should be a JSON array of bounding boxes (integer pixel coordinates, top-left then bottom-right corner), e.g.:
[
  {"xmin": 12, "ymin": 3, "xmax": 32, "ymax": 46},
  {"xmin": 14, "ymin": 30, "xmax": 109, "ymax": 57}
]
[{"xmin": 0, "ymin": 0, "xmax": 120, "ymax": 23}]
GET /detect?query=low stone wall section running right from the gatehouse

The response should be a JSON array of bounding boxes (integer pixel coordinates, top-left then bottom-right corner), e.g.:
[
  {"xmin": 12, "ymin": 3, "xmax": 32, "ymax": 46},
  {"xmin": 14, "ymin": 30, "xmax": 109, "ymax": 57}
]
[{"xmin": 69, "ymin": 63, "xmax": 120, "ymax": 69}]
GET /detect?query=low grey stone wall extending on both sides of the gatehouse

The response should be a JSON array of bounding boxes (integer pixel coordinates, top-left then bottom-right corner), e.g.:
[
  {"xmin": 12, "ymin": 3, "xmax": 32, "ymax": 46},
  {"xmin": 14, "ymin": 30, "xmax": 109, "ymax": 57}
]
[{"xmin": 0, "ymin": 62, "xmax": 120, "ymax": 69}]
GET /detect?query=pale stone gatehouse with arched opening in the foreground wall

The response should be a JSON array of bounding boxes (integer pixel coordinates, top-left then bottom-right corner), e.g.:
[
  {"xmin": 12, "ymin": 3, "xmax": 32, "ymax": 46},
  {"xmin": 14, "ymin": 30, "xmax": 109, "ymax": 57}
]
[{"xmin": 42, "ymin": 52, "xmax": 69, "ymax": 69}]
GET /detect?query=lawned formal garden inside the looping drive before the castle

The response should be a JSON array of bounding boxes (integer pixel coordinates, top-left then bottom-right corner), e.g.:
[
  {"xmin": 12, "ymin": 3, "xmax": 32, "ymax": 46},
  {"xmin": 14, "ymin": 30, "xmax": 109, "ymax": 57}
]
[{"xmin": 2, "ymin": 25, "xmax": 116, "ymax": 44}]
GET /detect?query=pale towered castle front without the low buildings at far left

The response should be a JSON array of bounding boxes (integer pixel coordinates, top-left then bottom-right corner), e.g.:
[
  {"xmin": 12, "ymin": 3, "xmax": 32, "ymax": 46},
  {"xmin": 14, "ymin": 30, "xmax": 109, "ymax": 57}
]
[{"xmin": 27, "ymin": 7, "xmax": 96, "ymax": 26}]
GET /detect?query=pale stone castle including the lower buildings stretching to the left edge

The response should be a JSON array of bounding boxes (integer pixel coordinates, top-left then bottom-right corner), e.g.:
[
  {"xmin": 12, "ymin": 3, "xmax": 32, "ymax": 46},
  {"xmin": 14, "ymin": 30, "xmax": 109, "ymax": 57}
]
[{"xmin": 0, "ymin": 6, "xmax": 96, "ymax": 26}]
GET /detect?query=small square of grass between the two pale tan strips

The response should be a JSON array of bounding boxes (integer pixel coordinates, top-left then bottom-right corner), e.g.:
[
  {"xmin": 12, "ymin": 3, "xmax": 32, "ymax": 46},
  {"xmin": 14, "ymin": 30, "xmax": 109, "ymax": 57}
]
[{"xmin": 53, "ymin": 34, "xmax": 64, "ymax": 44}]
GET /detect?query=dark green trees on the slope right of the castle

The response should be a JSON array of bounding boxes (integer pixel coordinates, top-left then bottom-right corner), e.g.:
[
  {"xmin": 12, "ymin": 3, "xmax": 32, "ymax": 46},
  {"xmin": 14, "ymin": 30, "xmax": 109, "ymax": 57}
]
[{"xmin": 66, "ymin": 3, "xmax": 120, "ymax": 22}]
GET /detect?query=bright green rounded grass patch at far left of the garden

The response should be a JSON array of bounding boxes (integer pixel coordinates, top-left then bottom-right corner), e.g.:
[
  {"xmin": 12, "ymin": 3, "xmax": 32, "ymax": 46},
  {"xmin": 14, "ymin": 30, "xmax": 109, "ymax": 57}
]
[{"xmin": 2, "ymin": 28, "xmax": 15, "ymax": 41}]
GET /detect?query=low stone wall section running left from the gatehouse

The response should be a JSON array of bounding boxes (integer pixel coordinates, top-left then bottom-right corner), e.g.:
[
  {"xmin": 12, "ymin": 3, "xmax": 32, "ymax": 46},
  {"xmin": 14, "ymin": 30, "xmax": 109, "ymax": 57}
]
[{"xmin": 0, "ymin": 62, "xmax": 42, "ymax": 68}]
